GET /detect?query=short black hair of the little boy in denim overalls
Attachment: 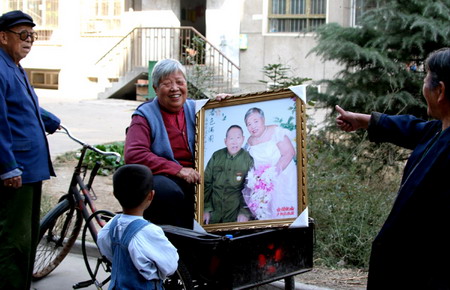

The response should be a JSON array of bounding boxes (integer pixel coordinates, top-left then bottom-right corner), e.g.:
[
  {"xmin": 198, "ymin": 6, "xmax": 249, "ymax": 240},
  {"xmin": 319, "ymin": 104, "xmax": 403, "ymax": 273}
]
[{"xmin": 113, "ymin": 164, "xmax": 153, "ymax": 209}]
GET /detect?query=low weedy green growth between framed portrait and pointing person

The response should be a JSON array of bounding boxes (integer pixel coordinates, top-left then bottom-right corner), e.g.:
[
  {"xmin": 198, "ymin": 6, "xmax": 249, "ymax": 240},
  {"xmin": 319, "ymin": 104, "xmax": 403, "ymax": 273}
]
[{"xmin": 308, "ymin": 135, "xmax": 400, "ymax": 268}]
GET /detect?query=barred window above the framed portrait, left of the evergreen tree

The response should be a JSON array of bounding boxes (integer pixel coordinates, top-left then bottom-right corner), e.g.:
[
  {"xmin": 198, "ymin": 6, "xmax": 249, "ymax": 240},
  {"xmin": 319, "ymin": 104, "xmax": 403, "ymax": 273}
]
[{"xmin": 268, "ymin": 0, "xmax": 327, "ymax": 33}]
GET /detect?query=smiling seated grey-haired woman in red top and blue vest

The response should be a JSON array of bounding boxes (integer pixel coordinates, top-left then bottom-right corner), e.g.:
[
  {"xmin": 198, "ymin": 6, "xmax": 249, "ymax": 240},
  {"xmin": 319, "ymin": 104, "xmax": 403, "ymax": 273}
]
[{"xmin": 124, "ymin": 59, "xmax": 226, "ymax": 228}]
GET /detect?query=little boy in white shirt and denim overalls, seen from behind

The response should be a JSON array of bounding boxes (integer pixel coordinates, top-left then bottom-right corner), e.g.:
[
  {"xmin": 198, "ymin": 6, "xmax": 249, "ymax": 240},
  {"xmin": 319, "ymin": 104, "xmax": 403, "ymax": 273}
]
[{"xmin": 97, "ymin": 164, "xmax": 178, "ymax": 289}]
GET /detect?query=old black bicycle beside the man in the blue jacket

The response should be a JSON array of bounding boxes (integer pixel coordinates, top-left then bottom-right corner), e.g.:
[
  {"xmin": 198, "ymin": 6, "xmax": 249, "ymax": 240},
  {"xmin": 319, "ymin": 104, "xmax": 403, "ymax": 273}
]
[{"xmin": 33, "ymin": 126, "xmax": 121, "ymax": 289}]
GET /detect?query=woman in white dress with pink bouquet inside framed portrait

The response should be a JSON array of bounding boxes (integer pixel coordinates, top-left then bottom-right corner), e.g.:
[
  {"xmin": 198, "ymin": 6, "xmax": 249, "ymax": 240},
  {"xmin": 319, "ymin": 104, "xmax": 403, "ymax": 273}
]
[{"xmin": 243, "ymin": 108, "xmax": 298, "ymax": 220}]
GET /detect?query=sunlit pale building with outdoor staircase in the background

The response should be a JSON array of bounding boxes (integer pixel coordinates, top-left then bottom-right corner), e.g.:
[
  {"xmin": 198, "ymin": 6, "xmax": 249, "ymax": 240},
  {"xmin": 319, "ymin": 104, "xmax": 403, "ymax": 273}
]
[{"xmin": 0, "ymin": 0, "xmax": 367, "ymax": 98}]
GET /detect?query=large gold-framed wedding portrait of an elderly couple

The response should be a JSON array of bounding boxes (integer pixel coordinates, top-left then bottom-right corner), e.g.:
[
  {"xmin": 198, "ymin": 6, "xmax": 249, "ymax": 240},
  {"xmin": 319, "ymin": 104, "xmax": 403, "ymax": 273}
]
[{"xmin": 195, "ymin": 89, "xmax": 307, "ymax": 232}]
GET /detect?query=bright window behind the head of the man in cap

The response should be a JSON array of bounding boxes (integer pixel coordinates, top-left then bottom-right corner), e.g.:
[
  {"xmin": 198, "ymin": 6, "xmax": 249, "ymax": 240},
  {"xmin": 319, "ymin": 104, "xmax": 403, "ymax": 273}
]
[{"xmin": 2, "ymin": 0, "xmax": 59, "ymax": 40}]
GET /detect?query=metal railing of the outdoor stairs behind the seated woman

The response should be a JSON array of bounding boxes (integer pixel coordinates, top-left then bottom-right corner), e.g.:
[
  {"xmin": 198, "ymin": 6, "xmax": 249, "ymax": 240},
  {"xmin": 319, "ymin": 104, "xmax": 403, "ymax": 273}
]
[{"xmin": 96, "ymin": 27, "xmax": 240, "ymax": 94}]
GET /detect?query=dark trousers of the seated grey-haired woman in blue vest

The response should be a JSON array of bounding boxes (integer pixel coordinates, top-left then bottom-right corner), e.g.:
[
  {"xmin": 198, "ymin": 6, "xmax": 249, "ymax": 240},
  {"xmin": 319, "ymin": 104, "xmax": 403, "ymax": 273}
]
[{"xmin": 144, "ymin": 175, "xmax": 195, "ymax": 229}]
